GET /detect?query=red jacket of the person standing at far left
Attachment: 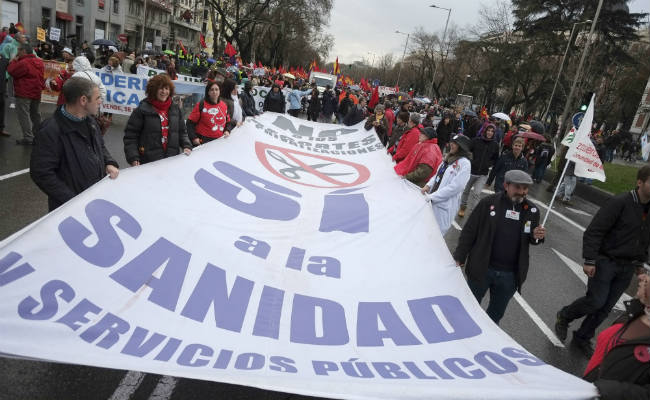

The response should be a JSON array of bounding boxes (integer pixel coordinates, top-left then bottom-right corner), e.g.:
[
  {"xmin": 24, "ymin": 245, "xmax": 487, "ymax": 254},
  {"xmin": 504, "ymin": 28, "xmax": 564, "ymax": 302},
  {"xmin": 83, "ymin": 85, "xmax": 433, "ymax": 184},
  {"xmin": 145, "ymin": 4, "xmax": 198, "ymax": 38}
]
[{"xmin": 7, "ymin": 54, "xmax": 45, "ymax": 100}]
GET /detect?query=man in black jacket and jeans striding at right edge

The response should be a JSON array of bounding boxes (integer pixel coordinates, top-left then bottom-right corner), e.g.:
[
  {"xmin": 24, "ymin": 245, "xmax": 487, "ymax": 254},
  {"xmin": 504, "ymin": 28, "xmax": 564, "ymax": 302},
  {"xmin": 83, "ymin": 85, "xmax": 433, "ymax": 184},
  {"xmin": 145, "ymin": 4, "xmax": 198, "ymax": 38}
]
[{"xmin": 555, "ymin": 165, "xmax": 650, "ymax": 357}]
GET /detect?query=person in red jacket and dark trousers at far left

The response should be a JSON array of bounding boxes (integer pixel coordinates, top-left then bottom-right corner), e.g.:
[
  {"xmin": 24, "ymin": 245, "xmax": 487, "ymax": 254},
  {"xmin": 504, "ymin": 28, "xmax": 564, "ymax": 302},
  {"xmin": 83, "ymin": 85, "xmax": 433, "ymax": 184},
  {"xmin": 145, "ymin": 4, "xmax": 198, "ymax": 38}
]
[{"xmin": 7, "ymin": 43, "xmax": 45, "ymax": 145}]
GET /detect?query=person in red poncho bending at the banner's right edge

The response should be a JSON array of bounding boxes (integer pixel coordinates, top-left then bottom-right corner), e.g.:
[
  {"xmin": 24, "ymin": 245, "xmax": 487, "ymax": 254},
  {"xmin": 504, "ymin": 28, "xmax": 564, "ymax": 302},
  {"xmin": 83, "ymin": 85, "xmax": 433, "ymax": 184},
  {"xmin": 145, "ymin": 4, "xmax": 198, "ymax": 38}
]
[{"xmin": 394, "ymin": 127, "xmax": 442, "ymax": 187}]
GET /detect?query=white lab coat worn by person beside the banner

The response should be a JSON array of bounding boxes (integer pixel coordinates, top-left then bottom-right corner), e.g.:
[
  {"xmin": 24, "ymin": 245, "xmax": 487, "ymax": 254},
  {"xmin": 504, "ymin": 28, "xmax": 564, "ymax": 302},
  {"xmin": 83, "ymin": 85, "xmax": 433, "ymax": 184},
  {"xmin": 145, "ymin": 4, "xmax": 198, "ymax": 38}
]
[{"xmin": 427, "ymin": 157, "xmax": 472, "ymax": 236}]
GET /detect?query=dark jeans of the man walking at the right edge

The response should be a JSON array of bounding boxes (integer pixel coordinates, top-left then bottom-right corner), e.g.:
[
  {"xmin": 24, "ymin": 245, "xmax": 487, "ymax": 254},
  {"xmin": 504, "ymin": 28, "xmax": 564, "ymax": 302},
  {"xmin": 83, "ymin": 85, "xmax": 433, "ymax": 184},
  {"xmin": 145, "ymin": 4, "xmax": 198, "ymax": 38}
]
[{"xmin": 560, "ymin": 259, "xmax": 636, "ymax": 340}]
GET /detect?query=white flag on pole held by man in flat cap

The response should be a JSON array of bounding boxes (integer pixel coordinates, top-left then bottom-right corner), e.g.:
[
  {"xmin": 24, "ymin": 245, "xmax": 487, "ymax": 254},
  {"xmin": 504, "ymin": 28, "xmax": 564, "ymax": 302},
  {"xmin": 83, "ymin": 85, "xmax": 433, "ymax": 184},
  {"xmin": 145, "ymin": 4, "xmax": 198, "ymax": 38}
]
[{"xmin": 563, "ymin": 96, "xmax": 605, "ymax": 182}]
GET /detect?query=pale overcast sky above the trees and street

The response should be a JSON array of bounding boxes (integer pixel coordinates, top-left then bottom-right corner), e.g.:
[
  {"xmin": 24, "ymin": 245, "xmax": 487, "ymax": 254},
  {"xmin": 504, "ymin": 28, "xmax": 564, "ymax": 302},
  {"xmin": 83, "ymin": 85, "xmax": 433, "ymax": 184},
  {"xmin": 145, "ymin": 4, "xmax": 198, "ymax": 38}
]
[{"xmin": 328, "ymin": 0, "xmax": 650, "ymax": 64}]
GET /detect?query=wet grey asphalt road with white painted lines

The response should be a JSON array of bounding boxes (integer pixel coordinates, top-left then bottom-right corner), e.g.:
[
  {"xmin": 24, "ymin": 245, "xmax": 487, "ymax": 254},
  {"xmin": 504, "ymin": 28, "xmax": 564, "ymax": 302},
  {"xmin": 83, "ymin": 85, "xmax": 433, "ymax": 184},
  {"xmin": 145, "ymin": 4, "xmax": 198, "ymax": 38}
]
[{"xmin": 0, "ymin": 104, "xmax": 636, "ymax": 400}]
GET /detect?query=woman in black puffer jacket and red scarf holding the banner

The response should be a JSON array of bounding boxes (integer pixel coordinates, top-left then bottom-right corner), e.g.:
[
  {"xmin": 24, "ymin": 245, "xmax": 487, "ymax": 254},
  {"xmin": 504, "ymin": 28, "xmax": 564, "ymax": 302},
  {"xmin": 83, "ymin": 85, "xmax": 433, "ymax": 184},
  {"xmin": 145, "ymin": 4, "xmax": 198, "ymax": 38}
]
[{"xmin": 124, "ymin": 74, "xmax": 192, "ymax": 166}]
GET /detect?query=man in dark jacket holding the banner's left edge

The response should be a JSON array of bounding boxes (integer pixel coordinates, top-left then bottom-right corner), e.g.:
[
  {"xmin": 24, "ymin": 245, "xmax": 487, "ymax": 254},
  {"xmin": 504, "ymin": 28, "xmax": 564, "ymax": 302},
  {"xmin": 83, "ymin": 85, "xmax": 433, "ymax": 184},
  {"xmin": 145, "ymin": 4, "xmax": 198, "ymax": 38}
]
[{"xmin": 29, "ymin": 78, "xmax": 119, "ymax": 211}]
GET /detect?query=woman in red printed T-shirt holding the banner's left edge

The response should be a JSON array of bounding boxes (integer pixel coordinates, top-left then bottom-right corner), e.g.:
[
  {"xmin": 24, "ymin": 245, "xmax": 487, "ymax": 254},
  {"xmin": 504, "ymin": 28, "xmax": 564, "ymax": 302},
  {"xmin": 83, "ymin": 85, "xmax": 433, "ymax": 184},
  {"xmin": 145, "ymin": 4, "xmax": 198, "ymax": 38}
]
[{"xmin": 186, "ymin": 81, "xmax": 235, "ymax": 146}]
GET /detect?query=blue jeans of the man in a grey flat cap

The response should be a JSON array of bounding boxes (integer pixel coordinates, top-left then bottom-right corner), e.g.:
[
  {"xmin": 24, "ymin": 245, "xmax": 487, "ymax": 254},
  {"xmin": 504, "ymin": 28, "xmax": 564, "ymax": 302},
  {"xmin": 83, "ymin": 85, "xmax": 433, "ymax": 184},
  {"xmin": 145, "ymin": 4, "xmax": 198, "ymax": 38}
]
[{"xmin": 467, "ymin": 267, "xmax": 517, "ymax": 325}]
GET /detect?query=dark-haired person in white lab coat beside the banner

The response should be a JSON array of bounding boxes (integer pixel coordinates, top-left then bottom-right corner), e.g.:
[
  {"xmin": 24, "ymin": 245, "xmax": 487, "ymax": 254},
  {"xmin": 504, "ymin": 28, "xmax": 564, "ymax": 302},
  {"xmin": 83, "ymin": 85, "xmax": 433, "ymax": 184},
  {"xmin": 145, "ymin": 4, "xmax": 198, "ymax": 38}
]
[{"xmin": 421, "ymin": 135, "xmax": 472, "ymax": 236}]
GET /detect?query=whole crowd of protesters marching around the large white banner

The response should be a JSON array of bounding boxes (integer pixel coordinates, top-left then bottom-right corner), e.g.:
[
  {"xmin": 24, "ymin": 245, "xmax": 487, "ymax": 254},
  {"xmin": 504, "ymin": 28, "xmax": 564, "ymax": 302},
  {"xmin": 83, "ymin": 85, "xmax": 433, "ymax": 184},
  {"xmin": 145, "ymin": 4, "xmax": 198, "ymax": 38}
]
[{"xmin": 0, "ymin": 19, "xmax": 650, "ymax": 399}]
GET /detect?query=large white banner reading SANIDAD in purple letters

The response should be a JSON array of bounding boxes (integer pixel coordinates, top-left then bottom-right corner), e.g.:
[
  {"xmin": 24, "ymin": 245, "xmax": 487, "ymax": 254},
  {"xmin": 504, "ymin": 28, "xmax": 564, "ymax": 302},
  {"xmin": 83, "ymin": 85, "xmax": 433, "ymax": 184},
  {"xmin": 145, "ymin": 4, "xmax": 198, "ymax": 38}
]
[{"xmin": 0, "ymin": 113, "xmax": 596, "ymax": 400}]
